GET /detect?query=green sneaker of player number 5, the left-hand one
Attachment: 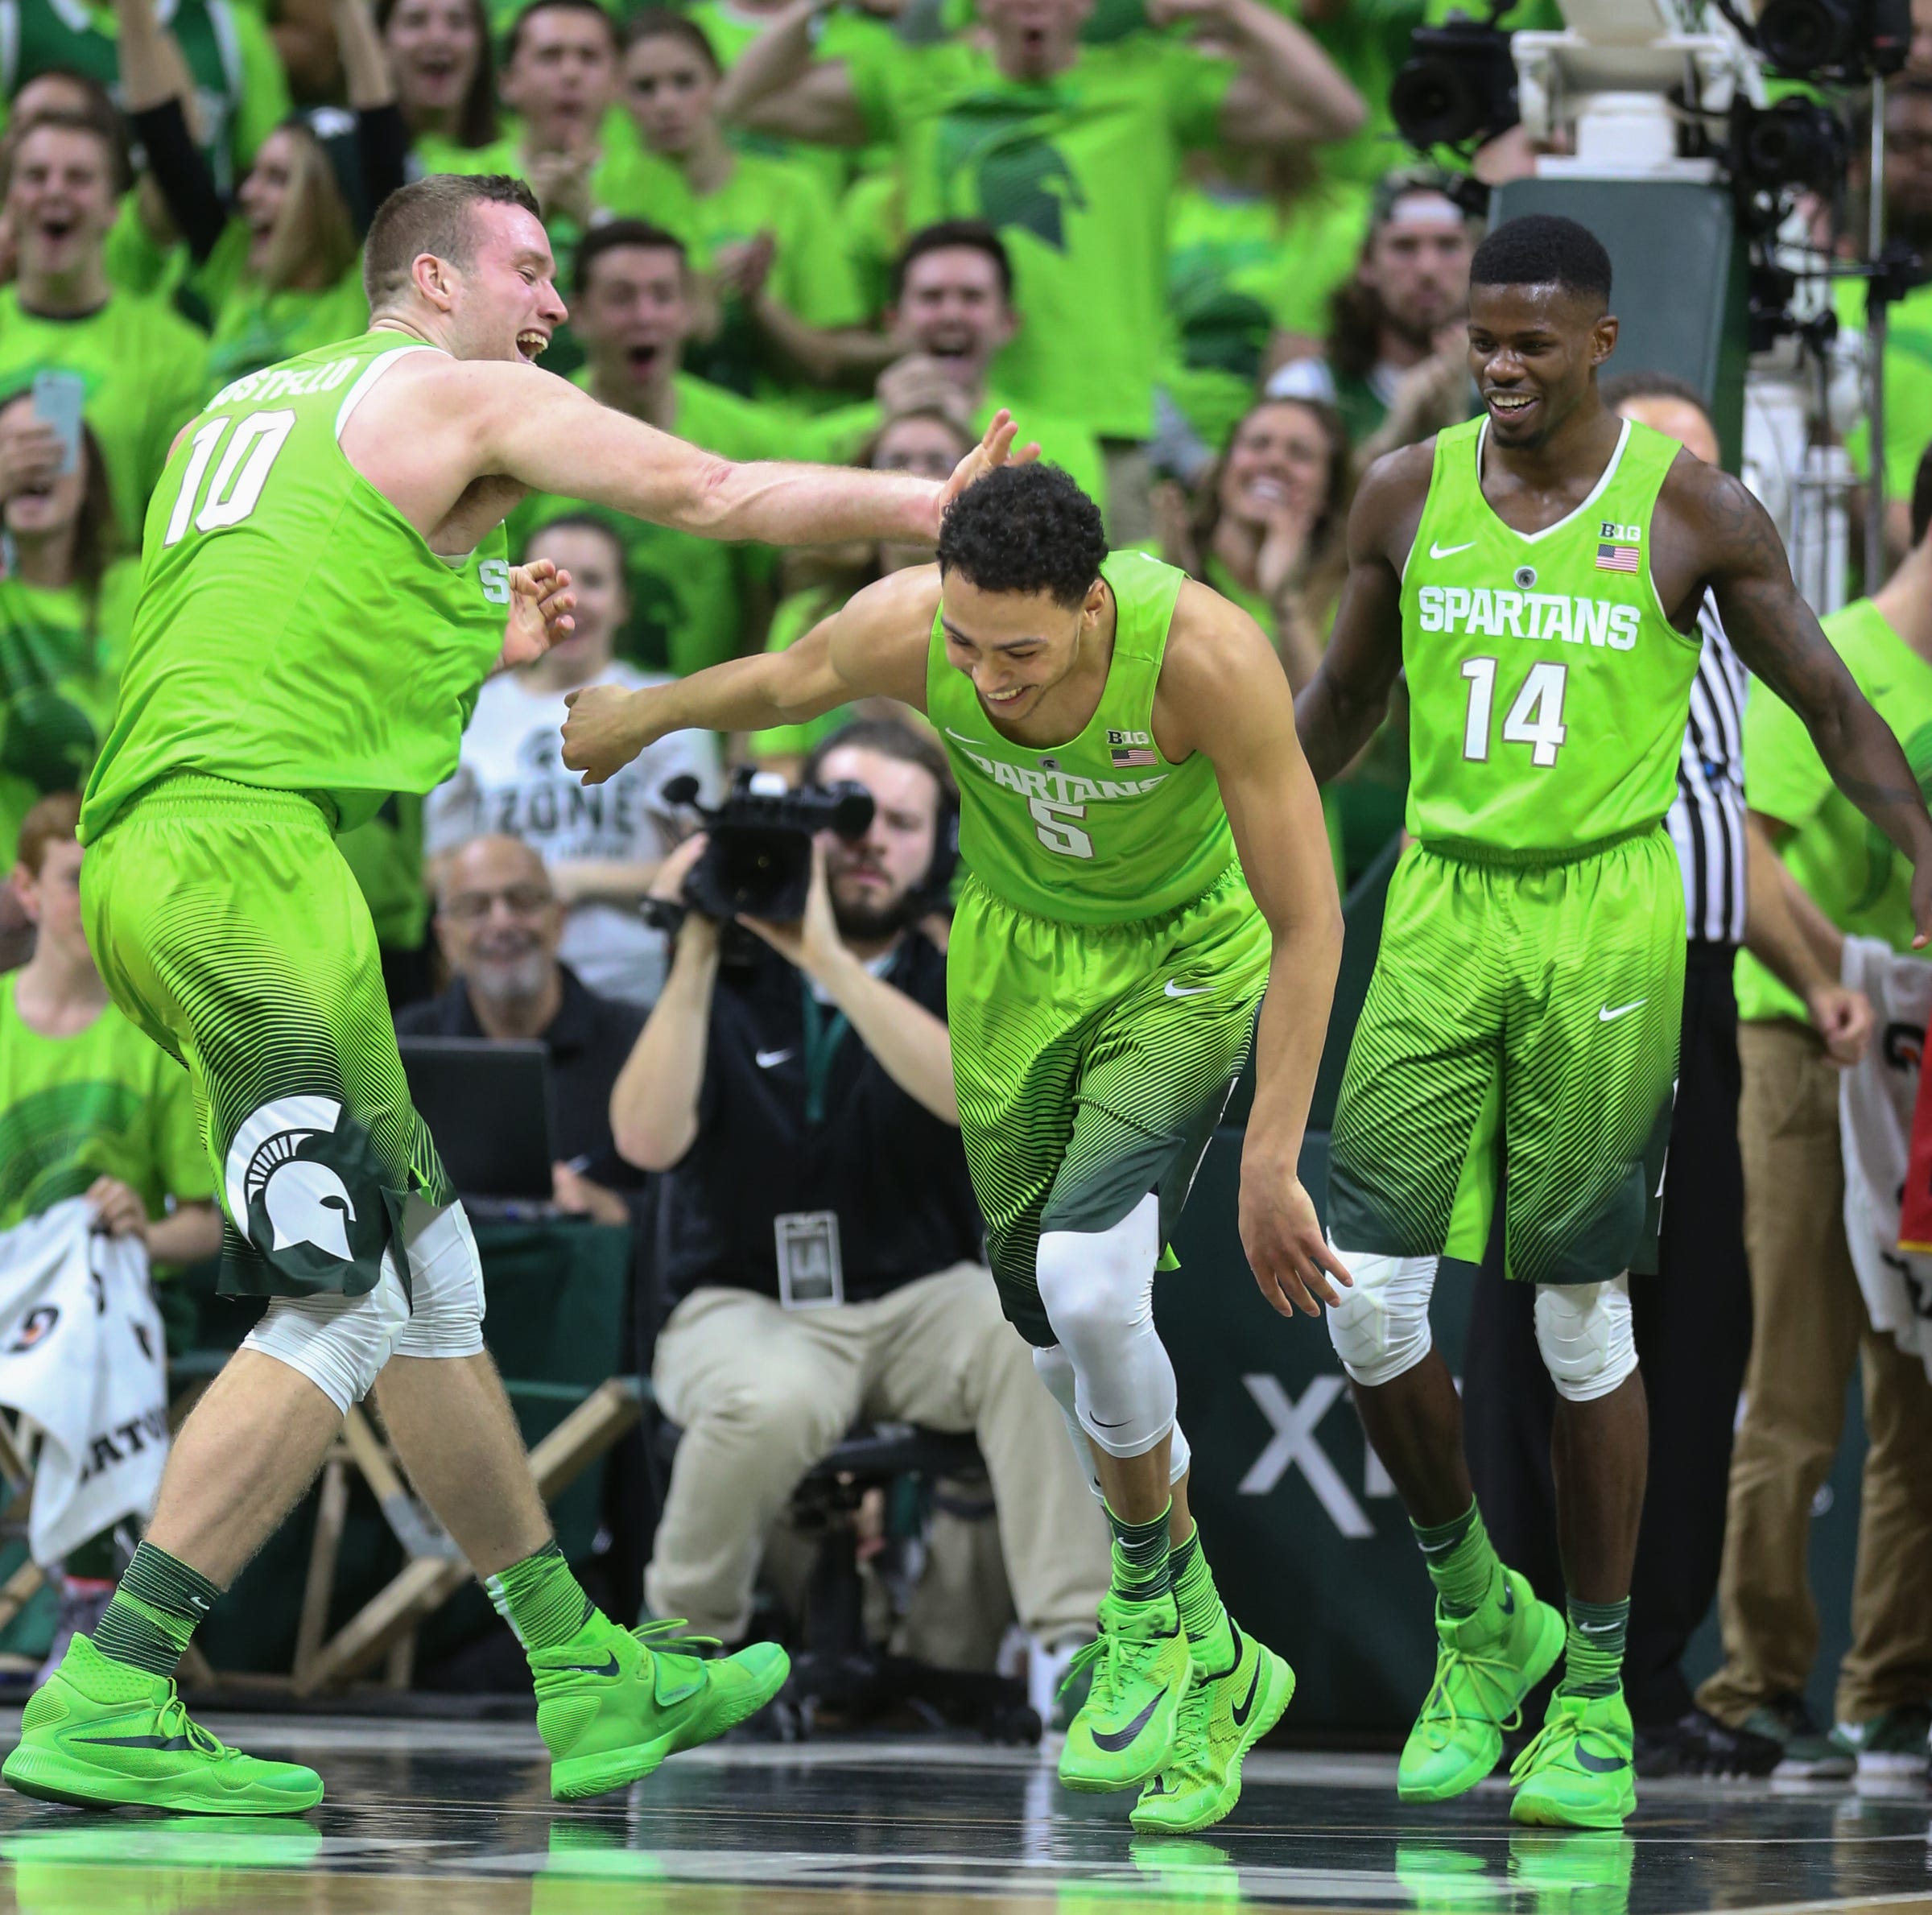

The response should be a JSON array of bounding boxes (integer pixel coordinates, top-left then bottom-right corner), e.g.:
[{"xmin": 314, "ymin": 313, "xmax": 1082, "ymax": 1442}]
[{"xmin": 1061, "ymin": 1592, "xmax": 1188, "ymax": 1795}]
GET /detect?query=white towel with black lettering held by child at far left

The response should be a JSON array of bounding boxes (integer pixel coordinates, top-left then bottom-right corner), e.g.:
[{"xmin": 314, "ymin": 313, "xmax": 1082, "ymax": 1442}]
[{"xmin": 0, "ymin": 1196, "xmax": 168, "ymax": 1565}]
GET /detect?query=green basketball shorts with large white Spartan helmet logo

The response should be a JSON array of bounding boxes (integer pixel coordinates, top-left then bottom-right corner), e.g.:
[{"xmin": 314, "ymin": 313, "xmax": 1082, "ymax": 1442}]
[{"xmin": 81, "ymin": 777, "xmax": 452, "ymax": 1297}]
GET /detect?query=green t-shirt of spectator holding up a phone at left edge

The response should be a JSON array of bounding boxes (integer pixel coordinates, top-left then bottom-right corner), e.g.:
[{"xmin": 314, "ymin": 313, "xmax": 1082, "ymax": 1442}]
[{"xmin": 0, "ymin": 559, "xmax": 141, "ymax": 869}]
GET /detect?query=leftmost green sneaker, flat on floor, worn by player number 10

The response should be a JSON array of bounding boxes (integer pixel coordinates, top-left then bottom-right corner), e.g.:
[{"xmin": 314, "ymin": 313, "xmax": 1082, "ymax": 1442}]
[{"xmin": 0, "ymin": 1635, "xmax": 323, "ymax": 1814}]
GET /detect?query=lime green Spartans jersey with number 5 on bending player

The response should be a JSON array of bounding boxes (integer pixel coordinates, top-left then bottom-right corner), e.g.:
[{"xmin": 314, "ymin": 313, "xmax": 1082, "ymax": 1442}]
[{"xmin": 926, "ymin": 553, "xmax": 1235, "ymax": 923}]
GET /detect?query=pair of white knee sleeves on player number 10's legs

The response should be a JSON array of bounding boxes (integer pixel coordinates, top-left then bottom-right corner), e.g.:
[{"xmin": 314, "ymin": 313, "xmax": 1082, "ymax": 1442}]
[{"xmin": 242, "ymin": 1196, "xmax": 483, "ymax": 1413}]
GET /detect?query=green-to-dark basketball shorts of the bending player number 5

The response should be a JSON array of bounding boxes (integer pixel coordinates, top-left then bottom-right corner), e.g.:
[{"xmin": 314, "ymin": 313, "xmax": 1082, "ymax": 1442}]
[{"xmin": 947, "ymin": 865, "xmax": 1271, "ymax": 1347}]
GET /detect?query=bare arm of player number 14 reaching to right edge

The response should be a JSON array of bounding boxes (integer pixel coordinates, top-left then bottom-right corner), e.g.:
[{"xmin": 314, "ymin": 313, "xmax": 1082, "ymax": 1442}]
[{"xmin": 1700, "ymin": 456, "xmax": 1932, "ymax": 947}]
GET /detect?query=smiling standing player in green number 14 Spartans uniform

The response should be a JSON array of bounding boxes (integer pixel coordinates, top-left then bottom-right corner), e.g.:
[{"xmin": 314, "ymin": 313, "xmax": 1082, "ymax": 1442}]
[{"xmin": 1298, "ymin": 214, "xmax": 1932, "ymax": 1828}]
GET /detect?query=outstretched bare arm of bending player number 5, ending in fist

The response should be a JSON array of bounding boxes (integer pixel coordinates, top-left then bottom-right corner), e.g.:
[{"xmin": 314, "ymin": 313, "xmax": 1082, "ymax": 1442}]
[{"xmin": 564, "ymin": 566, "xmax": 939, "ymax": 785}]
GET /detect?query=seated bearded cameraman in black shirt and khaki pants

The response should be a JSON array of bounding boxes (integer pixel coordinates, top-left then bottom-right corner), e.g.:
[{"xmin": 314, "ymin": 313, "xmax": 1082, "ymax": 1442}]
[{"xmin": 610, "ymin": 719, "xmax": 1107, "ymax": 1677}]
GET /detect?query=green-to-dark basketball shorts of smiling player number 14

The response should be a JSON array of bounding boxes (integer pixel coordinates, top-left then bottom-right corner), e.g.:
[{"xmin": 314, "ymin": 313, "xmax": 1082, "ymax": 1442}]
[{"xmin": 1329, "ymin": 829, "xmax": 1685, "ymax": 1283}]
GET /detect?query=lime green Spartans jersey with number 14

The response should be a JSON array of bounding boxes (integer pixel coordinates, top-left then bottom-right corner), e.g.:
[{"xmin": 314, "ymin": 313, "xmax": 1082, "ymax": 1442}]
[{"xmin": 1402, "ymin": 418, "xmax": 1700, "ymax": 862}]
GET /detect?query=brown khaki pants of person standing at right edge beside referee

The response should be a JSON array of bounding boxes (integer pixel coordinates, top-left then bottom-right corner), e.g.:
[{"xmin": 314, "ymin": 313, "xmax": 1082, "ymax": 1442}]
[{"xmin": 1686, "ymin": 1021, "xmax": 1932, "ymax": 1723}]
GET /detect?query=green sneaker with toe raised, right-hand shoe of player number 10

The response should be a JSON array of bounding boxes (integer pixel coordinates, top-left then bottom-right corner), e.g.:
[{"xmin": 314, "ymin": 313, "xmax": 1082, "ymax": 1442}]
[{"xmin": 530, "ymin": 1614, "xmax": 792, "ymax": 1801}]
